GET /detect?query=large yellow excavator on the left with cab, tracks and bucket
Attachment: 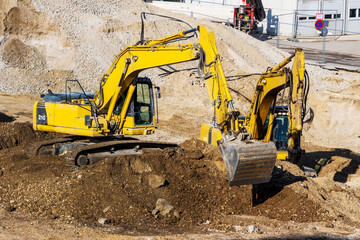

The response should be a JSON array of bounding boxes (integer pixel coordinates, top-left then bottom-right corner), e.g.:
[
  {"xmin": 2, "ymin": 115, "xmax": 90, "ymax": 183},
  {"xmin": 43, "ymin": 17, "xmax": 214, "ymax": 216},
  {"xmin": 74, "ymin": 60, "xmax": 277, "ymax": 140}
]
[{"xmin": 30, "ymin": 26, "xmax": 304, "ymax": 185}]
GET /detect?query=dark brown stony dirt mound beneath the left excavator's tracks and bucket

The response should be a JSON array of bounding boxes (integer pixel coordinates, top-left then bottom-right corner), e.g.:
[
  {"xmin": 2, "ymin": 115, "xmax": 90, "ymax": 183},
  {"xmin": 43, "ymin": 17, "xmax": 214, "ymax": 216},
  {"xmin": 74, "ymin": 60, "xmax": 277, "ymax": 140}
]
[{"xmin": 0, "ymin": 123, "xmax": 360, "ymax": 234}]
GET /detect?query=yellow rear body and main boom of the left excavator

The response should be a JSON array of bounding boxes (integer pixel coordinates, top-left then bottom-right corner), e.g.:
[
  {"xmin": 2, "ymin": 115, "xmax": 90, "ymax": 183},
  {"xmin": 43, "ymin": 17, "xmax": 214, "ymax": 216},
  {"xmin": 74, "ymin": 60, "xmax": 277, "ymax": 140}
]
[{"xmin": 34, "ymin": 29, "xmax": 199, "ymax": 137}]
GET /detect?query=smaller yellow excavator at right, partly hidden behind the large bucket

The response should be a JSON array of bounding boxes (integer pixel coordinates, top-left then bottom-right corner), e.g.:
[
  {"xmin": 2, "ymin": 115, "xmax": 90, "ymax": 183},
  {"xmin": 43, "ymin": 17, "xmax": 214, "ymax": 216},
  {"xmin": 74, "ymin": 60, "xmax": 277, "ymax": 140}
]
[{"xmin": 240, "ymin": 49, "xmax": 310, "ymax": 164}]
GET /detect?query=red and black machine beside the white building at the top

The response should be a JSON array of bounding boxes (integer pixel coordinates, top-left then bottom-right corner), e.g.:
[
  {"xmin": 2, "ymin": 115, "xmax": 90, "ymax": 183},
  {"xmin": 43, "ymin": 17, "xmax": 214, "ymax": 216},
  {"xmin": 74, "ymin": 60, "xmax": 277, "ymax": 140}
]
[{"xmin": 233, "ymin": 0, "xmax": 266, "ymax": 33}]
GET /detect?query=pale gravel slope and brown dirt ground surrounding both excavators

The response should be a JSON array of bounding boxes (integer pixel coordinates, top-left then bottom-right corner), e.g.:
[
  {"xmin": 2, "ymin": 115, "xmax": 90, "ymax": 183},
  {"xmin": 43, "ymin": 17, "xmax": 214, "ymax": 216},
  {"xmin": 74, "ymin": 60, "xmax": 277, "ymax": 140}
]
[{"xmin": 0, "ymin": 0, "xmax": 360, "ymax": 239}]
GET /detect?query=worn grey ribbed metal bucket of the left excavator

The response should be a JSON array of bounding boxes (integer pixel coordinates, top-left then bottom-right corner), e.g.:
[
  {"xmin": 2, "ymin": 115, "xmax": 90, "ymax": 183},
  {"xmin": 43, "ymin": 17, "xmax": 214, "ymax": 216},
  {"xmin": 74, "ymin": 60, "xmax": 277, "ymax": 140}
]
[{"xmin": 219, "ymin": 140, "xmax": 276, "ymax": 186}]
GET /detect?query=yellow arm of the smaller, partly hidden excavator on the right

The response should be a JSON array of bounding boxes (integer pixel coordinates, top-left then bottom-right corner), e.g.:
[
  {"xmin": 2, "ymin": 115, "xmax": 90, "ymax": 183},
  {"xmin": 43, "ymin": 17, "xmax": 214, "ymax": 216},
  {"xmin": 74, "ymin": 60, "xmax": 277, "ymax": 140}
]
[{"xmin": 244, "ymin": 49, "xmax": 308, "ymax": 163}]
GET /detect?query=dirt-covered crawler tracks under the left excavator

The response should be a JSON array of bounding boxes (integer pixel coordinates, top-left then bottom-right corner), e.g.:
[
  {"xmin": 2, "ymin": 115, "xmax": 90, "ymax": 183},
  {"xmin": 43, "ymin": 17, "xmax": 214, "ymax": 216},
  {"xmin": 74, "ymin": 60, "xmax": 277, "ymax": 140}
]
[{"xmin": 28, "ymin": 137, "xmax": 182, "ymax": 166}]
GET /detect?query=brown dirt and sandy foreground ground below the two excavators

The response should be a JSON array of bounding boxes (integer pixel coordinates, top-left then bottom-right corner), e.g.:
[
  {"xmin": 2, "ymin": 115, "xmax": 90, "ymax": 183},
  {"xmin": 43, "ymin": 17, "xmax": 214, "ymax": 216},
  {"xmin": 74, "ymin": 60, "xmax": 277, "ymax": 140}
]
[{"xmin": 0, "ymin": 93, "xmax": 360, "ymax": 239}]
